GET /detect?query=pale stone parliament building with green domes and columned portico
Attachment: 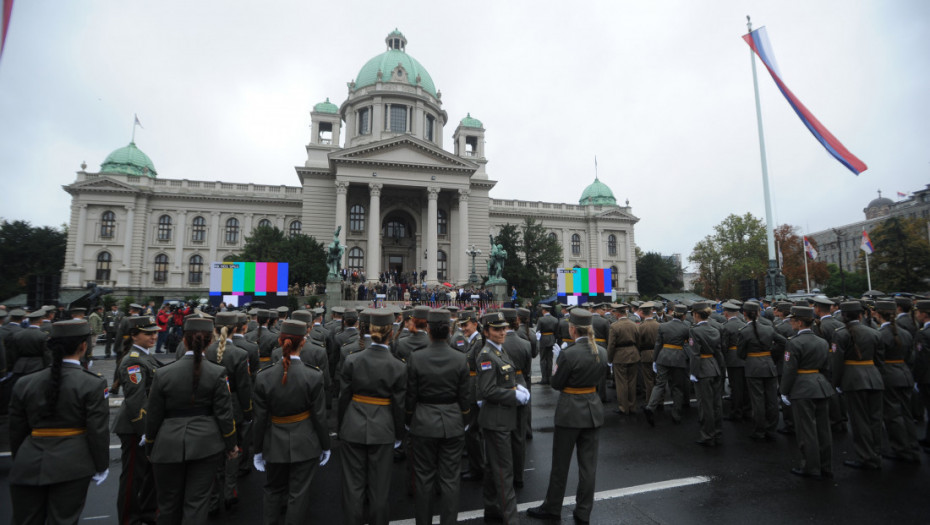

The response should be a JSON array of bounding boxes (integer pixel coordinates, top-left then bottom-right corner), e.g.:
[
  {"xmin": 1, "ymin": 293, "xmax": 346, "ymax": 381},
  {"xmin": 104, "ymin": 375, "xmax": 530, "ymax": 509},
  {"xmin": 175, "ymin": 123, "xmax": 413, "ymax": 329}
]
[{"xmin": 62, "ymin": 30, "xmax": 639, "ymax": 297}]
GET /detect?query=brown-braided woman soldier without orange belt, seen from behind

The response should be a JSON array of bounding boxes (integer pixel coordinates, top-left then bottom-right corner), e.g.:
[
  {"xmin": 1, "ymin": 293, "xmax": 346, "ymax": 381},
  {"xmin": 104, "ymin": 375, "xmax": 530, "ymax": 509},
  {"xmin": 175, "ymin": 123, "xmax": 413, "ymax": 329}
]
[{"xmin": 145, "ymin": 318, "xmax": 239, "ymax": 525}]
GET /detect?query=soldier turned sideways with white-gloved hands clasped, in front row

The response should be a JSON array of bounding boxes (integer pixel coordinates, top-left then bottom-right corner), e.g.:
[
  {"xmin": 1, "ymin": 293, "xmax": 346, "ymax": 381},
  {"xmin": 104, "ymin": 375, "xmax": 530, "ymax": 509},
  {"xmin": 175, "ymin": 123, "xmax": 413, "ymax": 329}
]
[{"xmin": 476, "ymin": 312, "xmax": 530, "ymax": 524}]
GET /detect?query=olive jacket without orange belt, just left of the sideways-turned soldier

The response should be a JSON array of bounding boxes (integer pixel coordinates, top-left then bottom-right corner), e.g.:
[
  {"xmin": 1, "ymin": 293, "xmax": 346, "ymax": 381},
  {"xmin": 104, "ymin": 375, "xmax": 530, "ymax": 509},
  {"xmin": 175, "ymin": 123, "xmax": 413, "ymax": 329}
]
[{"xmin": 406, "ymin": 341, "xmax": 471, "ymax": 438}]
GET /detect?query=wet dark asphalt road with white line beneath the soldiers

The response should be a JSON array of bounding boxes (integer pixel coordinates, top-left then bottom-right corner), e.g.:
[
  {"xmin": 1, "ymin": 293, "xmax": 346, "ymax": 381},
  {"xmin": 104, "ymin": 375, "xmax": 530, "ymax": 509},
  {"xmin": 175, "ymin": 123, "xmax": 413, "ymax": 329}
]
[{"xmin": 0, "ymin": 346, "xmax": 930, "ymax": 525}]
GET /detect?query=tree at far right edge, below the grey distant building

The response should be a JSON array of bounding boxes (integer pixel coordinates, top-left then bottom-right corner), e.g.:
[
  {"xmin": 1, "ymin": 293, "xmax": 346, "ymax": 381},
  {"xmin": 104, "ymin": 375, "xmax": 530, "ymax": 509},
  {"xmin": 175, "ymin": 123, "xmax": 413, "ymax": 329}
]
[{"xmin": 860, "ymin": 217, "xmax": 930, "ymax": 293}]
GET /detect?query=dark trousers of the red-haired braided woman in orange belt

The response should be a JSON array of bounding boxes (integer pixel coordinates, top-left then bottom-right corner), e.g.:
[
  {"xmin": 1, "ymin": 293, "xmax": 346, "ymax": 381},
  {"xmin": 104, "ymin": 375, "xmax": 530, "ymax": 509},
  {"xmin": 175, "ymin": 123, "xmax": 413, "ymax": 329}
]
[{"xmin": 263, "ymin": 458, "xmax": 318, "ymax": 525}]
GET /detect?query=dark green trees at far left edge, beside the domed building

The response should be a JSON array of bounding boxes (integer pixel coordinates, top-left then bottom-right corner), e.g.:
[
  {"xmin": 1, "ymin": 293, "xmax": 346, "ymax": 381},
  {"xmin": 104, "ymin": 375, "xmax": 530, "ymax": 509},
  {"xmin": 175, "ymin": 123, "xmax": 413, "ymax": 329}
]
[{"xmin": 0, "ymin": 221, "xmax": 68, "ymax": 300}]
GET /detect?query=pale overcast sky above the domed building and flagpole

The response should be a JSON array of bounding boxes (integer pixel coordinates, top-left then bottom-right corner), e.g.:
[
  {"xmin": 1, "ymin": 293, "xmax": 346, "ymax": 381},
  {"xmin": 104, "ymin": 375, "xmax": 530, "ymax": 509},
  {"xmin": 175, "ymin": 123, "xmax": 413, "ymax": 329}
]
[{"xmin": 0, "ymin": 0, "xmax": 930, "ymax": 270}]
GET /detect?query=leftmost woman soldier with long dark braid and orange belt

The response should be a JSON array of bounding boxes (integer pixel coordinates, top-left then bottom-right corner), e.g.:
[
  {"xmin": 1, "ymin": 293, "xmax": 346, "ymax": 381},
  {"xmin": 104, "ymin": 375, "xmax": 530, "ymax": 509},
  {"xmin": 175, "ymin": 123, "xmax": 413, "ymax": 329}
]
[{"xmin": 9, "ymin": 320, "xmax": 110, "ymax": 524}]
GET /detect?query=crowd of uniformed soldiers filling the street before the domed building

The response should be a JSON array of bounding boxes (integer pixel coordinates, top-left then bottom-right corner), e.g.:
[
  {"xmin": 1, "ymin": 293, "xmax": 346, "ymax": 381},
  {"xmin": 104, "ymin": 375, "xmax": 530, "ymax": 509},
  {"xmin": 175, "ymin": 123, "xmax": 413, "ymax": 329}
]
[{"xmin": 0, "ymin": 297, "xmax": 930, "ymax": 524}]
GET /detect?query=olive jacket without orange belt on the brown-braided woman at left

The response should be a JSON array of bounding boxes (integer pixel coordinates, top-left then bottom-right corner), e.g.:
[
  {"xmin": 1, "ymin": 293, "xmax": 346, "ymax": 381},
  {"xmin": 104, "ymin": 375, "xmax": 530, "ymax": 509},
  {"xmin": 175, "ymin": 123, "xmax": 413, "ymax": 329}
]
[{"xmin": 145, "ymin": 354, "xmax": 236, "ymax": 463}]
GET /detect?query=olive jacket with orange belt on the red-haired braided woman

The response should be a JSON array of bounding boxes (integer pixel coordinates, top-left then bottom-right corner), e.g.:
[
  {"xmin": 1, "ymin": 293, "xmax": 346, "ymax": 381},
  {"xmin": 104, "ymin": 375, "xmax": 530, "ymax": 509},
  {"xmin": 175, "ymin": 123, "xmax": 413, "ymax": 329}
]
[{"xmin": 252, "ymin": 356, "xmax": 332, "ymax": 463}]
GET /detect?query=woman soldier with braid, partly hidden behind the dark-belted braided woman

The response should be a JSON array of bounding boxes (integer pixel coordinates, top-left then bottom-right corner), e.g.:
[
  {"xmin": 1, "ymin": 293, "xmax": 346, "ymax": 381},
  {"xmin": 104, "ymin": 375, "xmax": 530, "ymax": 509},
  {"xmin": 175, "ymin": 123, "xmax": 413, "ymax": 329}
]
[{"xmin": 203, "ymin": 312, "xmax": 252, "ymax": 516}]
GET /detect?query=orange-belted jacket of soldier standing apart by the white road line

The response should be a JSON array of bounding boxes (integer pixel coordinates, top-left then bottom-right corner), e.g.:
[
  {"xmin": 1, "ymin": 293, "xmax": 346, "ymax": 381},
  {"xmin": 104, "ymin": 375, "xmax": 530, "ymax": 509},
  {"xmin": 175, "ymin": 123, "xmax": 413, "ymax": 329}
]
[{"xmin": 550, "ymin": 337, "xmax": 607, "ymax": 428}]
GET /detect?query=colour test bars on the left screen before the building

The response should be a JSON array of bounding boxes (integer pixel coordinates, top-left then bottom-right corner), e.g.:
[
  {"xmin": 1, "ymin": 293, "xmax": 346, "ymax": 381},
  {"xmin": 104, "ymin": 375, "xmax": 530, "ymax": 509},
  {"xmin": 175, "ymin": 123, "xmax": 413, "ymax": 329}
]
[{"xmin": 210, "ymin": 262, "xmax": 288, "ymax": 296}]
